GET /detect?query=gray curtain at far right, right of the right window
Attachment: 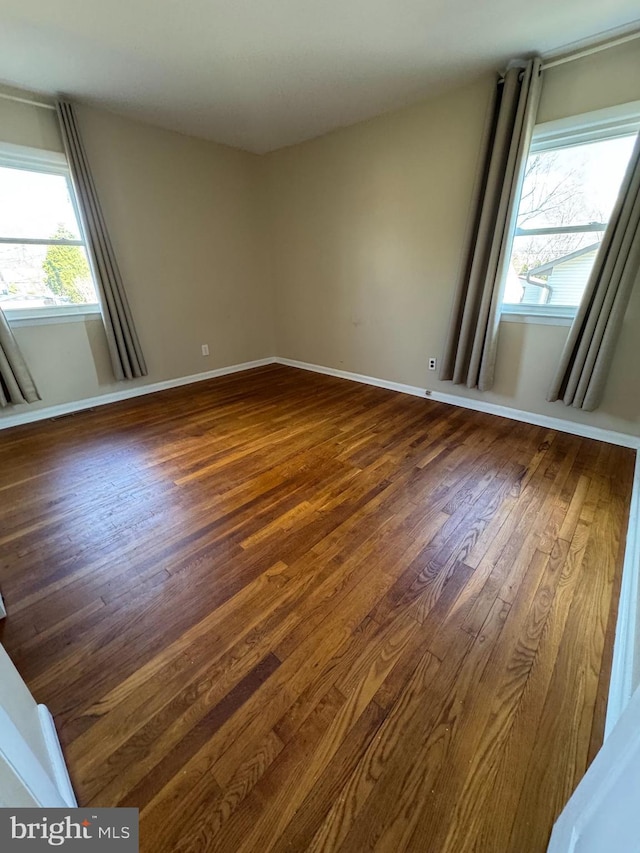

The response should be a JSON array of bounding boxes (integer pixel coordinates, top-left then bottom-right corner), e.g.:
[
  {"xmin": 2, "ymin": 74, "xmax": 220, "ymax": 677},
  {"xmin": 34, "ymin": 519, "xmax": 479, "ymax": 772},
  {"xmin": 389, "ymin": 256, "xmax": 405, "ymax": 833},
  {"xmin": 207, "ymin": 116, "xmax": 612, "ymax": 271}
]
[{"xmin": 547, "ymin": 134, "xmax": 640, "ymax": 412}]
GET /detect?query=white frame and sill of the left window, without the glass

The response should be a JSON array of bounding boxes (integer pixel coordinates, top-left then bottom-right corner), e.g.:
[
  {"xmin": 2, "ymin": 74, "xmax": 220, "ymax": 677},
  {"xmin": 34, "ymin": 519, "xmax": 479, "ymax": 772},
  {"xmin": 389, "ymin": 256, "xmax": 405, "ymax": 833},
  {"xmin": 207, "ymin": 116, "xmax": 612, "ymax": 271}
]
[{"xmin": 0, "ymin": 142, "xmax": 100, "ymax": 326}]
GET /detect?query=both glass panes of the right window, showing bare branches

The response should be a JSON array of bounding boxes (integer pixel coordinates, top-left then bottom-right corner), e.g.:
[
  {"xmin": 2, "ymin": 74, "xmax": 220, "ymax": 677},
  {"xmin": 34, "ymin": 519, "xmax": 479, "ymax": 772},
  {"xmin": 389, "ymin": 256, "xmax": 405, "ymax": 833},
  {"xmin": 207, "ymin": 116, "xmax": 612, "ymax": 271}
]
[{"xmin": 504, "ymin": 131, "xmax": 635, "ymax": 307}]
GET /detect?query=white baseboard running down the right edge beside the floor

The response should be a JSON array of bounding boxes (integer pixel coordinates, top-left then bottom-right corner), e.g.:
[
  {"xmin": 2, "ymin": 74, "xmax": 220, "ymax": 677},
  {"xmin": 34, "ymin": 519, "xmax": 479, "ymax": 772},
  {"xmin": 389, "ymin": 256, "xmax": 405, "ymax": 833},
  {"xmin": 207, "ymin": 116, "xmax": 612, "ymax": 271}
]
[{"xmin": 605, "ymin": 453, "xmax": 640, "ymax": 738}]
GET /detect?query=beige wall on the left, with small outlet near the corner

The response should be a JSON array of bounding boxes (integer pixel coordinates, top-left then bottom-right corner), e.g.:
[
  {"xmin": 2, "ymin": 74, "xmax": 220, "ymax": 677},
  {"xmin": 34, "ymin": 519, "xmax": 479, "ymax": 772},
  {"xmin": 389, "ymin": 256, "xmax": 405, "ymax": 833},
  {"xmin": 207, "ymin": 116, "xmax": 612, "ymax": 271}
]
[{"xmin": 0, "ymin": 91, "xmax": 275, "ymax": 418}]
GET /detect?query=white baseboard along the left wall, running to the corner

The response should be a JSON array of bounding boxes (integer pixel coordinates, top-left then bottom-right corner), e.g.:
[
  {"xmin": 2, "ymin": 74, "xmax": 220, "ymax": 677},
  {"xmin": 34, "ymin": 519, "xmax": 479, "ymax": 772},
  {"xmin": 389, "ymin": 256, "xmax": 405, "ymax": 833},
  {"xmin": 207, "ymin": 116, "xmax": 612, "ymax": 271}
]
[{"xmin": 0, "ymin": 358, "xmax": 274, "ymax": 429}]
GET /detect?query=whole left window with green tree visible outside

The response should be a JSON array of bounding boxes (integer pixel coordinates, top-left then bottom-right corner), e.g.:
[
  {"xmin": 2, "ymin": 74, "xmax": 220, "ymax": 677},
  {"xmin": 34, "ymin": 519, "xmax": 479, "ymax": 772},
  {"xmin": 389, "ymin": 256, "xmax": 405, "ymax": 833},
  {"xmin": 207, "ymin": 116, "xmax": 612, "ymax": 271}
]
[{"xmin": 0, "ymin": 145, "xmax": 98, "ymax": 318}]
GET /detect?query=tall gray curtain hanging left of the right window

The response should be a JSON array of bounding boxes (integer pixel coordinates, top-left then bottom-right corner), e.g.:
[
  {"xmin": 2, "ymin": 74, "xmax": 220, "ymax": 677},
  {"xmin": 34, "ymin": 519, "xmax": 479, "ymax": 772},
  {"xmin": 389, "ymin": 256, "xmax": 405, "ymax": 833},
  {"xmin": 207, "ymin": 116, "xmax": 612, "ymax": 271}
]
[{"xmin": 440, "ymin": 58, "xmax": 542, "ymax": 391}]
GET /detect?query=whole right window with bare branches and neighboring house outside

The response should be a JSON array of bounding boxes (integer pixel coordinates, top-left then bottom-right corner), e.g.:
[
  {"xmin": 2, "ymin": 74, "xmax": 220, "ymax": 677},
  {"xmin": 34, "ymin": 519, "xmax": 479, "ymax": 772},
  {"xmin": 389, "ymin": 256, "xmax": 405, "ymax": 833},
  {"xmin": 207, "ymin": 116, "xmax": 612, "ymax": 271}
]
[{"xmin": 503, "ymin": 105, "xmax": 639, "ymax": 317}]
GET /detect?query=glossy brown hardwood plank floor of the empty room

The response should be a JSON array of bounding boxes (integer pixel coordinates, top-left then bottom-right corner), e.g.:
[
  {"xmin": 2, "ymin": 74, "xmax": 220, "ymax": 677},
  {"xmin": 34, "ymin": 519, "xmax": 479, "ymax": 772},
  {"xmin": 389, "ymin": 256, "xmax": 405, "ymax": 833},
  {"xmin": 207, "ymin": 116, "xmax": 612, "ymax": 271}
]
[{"xmin": 0, "ymin": 366, "xmax": 633, "ymax": 853}]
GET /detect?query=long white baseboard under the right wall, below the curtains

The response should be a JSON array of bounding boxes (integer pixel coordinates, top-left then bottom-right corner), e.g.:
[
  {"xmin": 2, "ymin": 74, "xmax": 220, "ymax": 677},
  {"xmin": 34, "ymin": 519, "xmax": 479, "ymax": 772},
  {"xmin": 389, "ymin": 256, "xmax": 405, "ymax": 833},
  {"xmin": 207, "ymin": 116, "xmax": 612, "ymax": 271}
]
[{"xmin": 274, "ymin": 358, "xmax": 640, "ymax": 450}]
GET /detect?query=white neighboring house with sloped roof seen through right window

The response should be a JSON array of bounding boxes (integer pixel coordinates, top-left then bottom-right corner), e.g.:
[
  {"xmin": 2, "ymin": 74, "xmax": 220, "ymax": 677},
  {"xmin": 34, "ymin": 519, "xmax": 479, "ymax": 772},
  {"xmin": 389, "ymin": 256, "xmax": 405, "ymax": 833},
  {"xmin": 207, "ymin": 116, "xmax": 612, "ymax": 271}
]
[{"xmin": 518, "ymin": 242, "xmax": 600, "ymax": 305}]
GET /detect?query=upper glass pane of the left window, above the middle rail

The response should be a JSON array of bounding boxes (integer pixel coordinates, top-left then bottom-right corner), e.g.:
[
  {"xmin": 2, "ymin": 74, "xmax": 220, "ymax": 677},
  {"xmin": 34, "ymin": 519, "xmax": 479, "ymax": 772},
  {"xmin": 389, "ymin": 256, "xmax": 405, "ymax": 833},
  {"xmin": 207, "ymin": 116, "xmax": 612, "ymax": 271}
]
[{"xmin": 0, "ymin": 167, "xmax": 81, "ymax": 240}]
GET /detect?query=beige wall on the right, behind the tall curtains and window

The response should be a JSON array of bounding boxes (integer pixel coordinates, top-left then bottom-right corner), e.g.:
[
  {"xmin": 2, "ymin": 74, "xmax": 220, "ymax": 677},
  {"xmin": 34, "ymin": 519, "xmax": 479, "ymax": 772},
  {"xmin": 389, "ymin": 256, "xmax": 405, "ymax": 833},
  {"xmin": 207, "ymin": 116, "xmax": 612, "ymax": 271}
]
[{"xmin": 265, "ymin": 42, "xmax": 640, "ymax": 435}]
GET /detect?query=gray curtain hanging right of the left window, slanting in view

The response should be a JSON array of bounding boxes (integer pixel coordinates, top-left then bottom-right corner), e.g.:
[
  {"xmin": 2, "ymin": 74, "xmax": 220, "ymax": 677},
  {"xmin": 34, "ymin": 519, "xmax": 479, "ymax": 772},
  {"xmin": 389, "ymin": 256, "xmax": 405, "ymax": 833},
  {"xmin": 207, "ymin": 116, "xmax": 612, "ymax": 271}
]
[{"xmin": 56, "ymin": 101, "xmax": 147, "ymax": 379}]
